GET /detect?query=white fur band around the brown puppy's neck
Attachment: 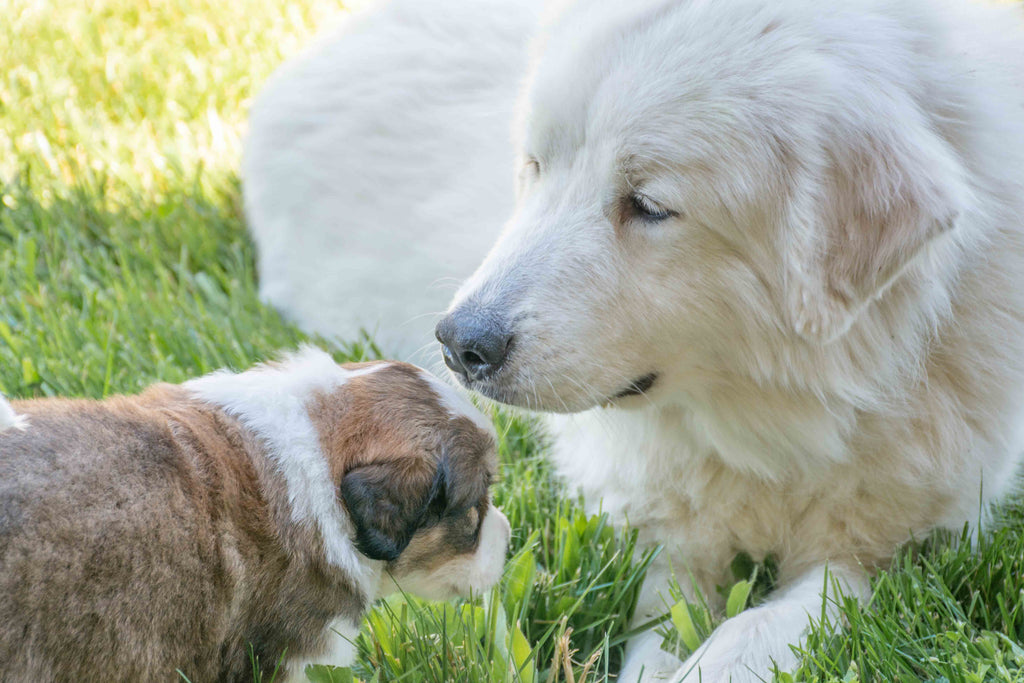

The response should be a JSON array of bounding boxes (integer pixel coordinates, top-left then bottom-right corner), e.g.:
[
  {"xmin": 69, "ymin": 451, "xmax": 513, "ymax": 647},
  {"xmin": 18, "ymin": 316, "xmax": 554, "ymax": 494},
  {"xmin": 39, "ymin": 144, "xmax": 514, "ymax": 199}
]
[{"xmin": 184, "ymin": 346, "xmax": 387, "ymax": 595}]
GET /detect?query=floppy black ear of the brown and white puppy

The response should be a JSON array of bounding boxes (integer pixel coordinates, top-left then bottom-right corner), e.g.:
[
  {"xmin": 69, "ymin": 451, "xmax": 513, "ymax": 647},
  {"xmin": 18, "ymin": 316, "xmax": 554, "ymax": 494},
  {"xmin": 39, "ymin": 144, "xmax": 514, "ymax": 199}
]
[{"xmin": 339, "ymin": 464, "xmax": 443, "ymax": 561}]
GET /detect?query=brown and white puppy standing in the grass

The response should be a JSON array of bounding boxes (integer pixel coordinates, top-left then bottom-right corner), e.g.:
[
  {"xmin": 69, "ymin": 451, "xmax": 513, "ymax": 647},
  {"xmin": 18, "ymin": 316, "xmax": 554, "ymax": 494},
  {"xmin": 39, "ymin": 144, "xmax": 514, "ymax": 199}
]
[{"xmin": 0, "ymin": 349, "xmax": 509, "ymax": 682}]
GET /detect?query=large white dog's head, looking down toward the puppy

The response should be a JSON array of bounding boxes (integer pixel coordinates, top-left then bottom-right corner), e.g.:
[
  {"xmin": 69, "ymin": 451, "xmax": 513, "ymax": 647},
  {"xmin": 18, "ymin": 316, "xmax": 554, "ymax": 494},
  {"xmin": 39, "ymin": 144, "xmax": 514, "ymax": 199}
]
[{"xmin": 437, "ymin": 0, "xmax": 970, "ymax": 412}]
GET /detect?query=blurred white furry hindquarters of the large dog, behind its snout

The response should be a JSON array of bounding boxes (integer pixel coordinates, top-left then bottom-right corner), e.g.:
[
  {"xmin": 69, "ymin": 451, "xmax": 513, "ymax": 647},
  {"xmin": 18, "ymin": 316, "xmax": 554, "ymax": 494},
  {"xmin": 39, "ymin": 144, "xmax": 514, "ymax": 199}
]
[{"xmin": 242, "ymin": 0, "xmax": 539, "ymax": 360}]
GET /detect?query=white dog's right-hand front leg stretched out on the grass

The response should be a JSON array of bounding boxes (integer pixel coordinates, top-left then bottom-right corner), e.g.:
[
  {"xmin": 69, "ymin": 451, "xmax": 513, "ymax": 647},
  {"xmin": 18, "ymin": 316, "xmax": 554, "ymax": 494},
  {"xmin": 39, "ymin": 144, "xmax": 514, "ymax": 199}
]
[{"xmin": 672, "ymin": 565, "xmax": 870, "ymax": 683}]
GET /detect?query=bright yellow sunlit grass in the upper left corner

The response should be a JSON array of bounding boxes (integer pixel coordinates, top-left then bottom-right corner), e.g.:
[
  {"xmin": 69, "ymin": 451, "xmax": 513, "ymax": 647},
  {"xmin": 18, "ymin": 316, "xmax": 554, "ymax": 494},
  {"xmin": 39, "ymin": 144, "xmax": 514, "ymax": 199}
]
[{"xmin": 0, "ymin": 0, "xmax": 341, "ymax": 194}]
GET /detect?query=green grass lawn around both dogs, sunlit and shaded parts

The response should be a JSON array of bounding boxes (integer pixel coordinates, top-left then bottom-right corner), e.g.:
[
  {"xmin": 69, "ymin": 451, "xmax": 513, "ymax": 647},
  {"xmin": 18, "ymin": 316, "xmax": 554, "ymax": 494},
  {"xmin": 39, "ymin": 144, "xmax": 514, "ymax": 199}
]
[{"xmin": 0, "ymin": 0, "xmax": 1024, "ymax": 683}]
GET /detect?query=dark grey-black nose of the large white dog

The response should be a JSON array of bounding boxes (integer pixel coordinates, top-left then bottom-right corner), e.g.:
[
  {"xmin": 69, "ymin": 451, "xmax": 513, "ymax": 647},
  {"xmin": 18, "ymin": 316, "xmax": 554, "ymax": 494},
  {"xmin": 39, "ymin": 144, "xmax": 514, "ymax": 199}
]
[{"xmin": 434, "ymin": 306, "xmax": 512, "ymax": 380}]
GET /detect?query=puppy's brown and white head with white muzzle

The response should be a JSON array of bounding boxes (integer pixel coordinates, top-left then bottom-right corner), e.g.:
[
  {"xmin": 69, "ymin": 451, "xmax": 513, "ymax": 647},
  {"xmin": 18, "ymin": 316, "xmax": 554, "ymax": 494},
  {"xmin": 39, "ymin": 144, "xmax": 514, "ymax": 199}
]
[{"xmin": 311, "ymin": 362, "xmax": 510, "ymax": 599}]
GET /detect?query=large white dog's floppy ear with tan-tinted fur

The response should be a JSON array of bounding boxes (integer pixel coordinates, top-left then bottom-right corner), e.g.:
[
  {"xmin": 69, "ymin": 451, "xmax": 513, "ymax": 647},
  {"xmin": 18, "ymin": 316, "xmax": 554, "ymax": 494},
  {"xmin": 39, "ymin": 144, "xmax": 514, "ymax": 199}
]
[{"xmin": 786, "ymin": 113, "xmax": 970, "ymax": 343}]
